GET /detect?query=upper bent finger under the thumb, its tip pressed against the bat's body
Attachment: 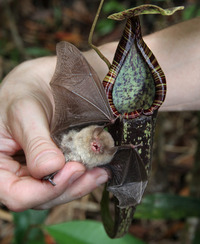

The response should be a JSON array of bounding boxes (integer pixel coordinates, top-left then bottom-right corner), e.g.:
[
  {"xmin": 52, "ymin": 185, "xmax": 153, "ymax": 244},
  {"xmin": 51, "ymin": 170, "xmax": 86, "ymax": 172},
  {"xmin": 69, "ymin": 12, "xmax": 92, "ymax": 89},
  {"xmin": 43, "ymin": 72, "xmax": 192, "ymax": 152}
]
[{"xmin": 0, "ymin": 162, "xmax": 85, "ymax": 211}]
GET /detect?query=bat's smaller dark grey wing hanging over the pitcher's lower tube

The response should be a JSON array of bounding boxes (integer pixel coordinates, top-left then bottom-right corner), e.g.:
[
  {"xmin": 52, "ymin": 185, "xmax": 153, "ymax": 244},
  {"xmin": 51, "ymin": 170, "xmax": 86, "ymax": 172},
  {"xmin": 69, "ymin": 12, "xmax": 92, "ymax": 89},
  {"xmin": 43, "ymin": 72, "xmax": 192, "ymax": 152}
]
[{"xmin": 106, "ymin": 148, "xmax": 148, "ymax": 208}]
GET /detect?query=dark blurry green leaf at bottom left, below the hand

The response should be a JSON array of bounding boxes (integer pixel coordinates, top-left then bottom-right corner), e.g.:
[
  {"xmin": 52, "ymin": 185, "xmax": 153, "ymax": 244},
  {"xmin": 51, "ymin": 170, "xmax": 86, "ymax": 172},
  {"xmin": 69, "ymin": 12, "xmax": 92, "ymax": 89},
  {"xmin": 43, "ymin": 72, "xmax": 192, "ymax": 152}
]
[{"xmin": 13, "ymin": 210, "xmax": 48, "ymax": 244}]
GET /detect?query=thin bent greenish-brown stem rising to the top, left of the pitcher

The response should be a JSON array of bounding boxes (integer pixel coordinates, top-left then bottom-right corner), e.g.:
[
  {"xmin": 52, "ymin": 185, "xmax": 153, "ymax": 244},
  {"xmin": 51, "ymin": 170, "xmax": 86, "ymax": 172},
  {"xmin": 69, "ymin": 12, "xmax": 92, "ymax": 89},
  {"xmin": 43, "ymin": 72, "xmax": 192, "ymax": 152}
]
[{"xmin": 88, "ymin": 0, "xmax": 111, "ymax": 68}]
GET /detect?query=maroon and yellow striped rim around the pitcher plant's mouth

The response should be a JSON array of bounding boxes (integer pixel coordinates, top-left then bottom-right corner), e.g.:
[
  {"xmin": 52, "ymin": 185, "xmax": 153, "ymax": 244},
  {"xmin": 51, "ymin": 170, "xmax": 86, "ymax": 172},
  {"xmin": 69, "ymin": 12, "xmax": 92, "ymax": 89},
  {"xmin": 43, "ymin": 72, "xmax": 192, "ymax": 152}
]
[{"xmin": 103, "ymin": 17, "xmax": 166, "ymax": 119}]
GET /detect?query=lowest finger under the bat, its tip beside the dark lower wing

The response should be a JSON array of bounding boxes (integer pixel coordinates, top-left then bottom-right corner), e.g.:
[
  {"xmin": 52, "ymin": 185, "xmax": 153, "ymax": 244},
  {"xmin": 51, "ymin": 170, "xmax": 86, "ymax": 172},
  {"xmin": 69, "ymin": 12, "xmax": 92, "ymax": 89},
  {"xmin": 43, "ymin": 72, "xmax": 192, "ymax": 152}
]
[{"xmin": 35, "ymin": 168, "xmax": 108, "ymax": 209}]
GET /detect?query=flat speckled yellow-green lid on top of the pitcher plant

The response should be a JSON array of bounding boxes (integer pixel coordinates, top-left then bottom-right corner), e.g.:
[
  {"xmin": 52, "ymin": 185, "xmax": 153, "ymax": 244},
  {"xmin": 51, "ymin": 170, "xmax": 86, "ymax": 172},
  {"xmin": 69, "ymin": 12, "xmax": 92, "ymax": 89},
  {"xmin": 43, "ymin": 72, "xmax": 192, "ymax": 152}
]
[{"xmin": 108, "ymin": 4, "xmax": 184, "ymax": 20}]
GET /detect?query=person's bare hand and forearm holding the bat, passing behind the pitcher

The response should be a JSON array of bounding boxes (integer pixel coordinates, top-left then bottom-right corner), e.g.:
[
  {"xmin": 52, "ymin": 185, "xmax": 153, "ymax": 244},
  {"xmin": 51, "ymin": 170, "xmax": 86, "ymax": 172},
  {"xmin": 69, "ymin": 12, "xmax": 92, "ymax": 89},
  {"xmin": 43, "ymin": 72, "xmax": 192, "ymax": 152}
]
[{"xmin": 0, "ymin": 18, "xmax": 200, "ymax": 211}]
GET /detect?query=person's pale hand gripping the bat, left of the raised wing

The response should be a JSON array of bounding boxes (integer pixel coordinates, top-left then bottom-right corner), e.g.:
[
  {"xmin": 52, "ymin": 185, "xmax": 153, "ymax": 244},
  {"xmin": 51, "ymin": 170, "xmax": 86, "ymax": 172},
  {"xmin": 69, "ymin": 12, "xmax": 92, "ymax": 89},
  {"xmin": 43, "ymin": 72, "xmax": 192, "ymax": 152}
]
[{"xmin": 0, "ymin": 57, "xmax": 108, "ymax": 211}]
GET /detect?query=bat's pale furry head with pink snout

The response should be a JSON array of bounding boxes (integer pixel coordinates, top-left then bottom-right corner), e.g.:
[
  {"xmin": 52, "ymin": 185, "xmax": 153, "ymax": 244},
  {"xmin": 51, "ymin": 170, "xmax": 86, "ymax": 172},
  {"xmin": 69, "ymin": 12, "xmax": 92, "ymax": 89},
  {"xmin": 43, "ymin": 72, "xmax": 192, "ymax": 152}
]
[{"xmin": 75, "ymin": 125, "xmax": 116, "ymax": 168}]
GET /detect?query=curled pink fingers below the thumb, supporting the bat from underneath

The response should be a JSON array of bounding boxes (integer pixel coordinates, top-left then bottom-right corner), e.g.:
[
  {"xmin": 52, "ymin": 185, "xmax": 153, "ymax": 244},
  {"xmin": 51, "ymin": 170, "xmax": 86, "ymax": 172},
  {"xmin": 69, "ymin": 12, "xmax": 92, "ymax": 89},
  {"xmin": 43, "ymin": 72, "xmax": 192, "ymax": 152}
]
[{"xmin": 0, "ymin": 157, "xmax": 108, "ymax": 211}]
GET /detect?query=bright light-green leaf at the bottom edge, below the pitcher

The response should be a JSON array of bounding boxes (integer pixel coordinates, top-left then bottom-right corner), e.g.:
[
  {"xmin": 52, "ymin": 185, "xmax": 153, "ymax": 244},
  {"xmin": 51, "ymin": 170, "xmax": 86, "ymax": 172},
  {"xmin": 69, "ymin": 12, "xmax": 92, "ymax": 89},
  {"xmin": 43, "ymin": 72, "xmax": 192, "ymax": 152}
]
[{"xmin": 44, "ymin": 220, "xmax": 145, "ymax": 244}]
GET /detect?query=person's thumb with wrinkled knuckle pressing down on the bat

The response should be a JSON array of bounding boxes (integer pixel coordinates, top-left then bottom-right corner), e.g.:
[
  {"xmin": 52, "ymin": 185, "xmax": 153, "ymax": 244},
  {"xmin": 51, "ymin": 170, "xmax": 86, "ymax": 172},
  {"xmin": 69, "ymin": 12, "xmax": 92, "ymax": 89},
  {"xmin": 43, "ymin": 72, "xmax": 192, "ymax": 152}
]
[{"xmin": 8, "ymin": 98, "xmax": 65, "ymax": 179}]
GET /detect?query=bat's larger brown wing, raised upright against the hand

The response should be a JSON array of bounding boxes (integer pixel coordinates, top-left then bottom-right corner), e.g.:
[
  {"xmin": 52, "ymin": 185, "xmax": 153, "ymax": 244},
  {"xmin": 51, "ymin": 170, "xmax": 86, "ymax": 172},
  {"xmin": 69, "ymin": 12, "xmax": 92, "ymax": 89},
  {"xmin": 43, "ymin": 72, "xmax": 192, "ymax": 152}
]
[{"xmin": 50, "ymin": 42, "xmax": 113, "ymax": 139}]
